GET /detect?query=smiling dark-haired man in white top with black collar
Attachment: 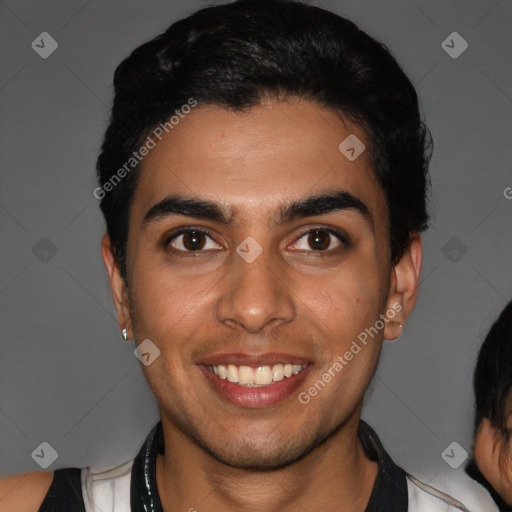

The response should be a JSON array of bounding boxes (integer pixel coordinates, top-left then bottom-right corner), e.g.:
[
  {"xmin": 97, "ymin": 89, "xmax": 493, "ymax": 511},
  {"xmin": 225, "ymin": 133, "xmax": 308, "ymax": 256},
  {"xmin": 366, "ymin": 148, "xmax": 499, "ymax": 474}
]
[{"xmin": 0, "ymin": 0, "xmax": 498, "ymax": 512}]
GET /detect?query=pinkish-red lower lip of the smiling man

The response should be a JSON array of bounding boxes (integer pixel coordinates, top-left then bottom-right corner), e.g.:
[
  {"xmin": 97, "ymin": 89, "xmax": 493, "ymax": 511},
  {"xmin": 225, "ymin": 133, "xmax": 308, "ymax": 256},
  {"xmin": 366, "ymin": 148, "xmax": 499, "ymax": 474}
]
[{"xmin": 198, "ymin": 364, "xmax": 313, "ymax": 409}]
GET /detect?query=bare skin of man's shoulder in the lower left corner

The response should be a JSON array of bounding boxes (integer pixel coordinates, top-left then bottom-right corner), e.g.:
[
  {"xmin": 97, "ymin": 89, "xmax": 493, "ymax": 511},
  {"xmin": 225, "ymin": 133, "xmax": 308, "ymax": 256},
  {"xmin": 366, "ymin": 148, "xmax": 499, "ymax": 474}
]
[{"xmin": 0, "ymin": 471, "xmax": 54, "ymax": 512}]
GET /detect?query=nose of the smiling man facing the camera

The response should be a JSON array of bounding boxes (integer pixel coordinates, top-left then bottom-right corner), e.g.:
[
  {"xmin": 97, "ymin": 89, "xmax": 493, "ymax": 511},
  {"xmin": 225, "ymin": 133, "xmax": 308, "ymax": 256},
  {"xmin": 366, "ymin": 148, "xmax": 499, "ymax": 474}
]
[{"xmin": 216, "ymin": 243, "xmax": 296, "ymax": 333}]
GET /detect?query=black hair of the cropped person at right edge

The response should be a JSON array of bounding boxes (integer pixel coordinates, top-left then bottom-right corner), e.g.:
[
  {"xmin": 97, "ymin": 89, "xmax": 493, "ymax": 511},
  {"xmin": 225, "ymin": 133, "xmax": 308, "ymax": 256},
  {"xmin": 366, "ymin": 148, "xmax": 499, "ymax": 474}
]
[{"xmin": 473, "ymin": 301, "xmax": 512, "ymax": 470}]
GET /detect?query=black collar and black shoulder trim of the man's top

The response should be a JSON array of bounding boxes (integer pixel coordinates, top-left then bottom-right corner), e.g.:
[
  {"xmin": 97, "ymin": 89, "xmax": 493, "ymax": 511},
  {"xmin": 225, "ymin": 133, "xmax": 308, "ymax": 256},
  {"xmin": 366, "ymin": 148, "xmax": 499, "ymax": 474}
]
[{"xmin": 39, "ymin": 420, "xmax": 408, "ymax": 512}]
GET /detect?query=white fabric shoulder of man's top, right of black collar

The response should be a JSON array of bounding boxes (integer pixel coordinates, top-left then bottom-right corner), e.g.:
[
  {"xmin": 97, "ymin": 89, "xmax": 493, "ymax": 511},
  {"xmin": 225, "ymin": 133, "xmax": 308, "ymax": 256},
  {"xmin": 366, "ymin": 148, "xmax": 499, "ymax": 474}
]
[{"xmin": 407, "ymin": 472, "xmax": 498, "ymax": 512}]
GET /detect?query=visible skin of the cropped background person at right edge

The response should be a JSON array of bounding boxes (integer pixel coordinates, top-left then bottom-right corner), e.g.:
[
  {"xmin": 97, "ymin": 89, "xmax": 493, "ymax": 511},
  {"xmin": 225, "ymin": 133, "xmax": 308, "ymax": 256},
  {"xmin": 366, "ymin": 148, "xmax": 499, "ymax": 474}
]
[{"xmin": 473, "ymin": 393, "xmax": 512, "ymax": 506}]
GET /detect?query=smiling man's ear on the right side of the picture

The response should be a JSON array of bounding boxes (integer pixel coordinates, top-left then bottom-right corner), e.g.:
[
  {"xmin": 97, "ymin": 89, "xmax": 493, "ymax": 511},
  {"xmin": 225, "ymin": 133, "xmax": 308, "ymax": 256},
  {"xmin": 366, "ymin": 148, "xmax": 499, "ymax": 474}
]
[{"xmin": 384, "ymin": 233, "xmax": 423, "ymax": 340}]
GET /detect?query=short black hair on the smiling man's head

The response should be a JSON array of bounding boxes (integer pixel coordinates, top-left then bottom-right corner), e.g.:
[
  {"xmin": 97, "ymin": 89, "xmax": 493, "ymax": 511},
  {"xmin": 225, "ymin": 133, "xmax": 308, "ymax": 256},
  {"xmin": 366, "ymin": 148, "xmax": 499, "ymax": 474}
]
[{"xmin": 95, "ymin": 0, "xmax": 432, "ymax": 284}]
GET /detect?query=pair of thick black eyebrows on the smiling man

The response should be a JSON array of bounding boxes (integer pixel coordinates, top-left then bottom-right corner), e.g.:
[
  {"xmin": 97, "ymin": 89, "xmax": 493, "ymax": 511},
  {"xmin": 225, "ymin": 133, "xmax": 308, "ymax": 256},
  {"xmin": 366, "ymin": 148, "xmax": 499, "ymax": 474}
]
[{"xmin": 142, "ymin": 190, "xmax": 372, "ymax": 229}]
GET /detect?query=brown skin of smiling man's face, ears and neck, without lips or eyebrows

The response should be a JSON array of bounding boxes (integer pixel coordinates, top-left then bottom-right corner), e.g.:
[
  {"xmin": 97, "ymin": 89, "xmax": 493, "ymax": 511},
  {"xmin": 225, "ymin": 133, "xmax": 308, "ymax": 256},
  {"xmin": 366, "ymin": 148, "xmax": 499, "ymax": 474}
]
[{"xmin": 0, "ymin": 100, "xmax": 422, "ymax": 512}]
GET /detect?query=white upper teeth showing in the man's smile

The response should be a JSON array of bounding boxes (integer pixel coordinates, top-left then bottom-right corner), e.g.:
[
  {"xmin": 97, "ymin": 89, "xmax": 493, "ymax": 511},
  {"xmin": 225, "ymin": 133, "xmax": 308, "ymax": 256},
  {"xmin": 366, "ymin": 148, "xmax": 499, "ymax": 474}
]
[{"xmin": 208, "ymin": 364, "xmax": 307, "ymax": 387}]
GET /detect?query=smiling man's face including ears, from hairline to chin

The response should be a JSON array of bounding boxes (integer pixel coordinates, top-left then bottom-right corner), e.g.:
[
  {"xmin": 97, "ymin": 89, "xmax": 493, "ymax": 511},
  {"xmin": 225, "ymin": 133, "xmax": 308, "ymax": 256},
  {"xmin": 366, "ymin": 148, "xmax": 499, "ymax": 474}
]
[{"xmin": 103, "ymin": 101, "xmax": 421, "ymax": 469}]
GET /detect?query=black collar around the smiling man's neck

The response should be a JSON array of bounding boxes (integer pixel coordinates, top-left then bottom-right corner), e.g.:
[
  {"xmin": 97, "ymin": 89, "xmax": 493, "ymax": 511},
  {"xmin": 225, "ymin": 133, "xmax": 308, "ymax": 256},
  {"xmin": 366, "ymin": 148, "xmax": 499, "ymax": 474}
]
[{"xmin": 130, "ymin": 420, "xmax": 408, "ymax": 512}]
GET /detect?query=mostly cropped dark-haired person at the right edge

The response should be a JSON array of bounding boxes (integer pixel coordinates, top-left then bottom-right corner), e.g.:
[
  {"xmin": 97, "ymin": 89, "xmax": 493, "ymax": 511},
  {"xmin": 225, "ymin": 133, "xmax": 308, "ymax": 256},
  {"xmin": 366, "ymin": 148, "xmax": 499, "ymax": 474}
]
[{"xmin": 465, "ymin": 301, "xmax": 512, "ymax": 512}]
